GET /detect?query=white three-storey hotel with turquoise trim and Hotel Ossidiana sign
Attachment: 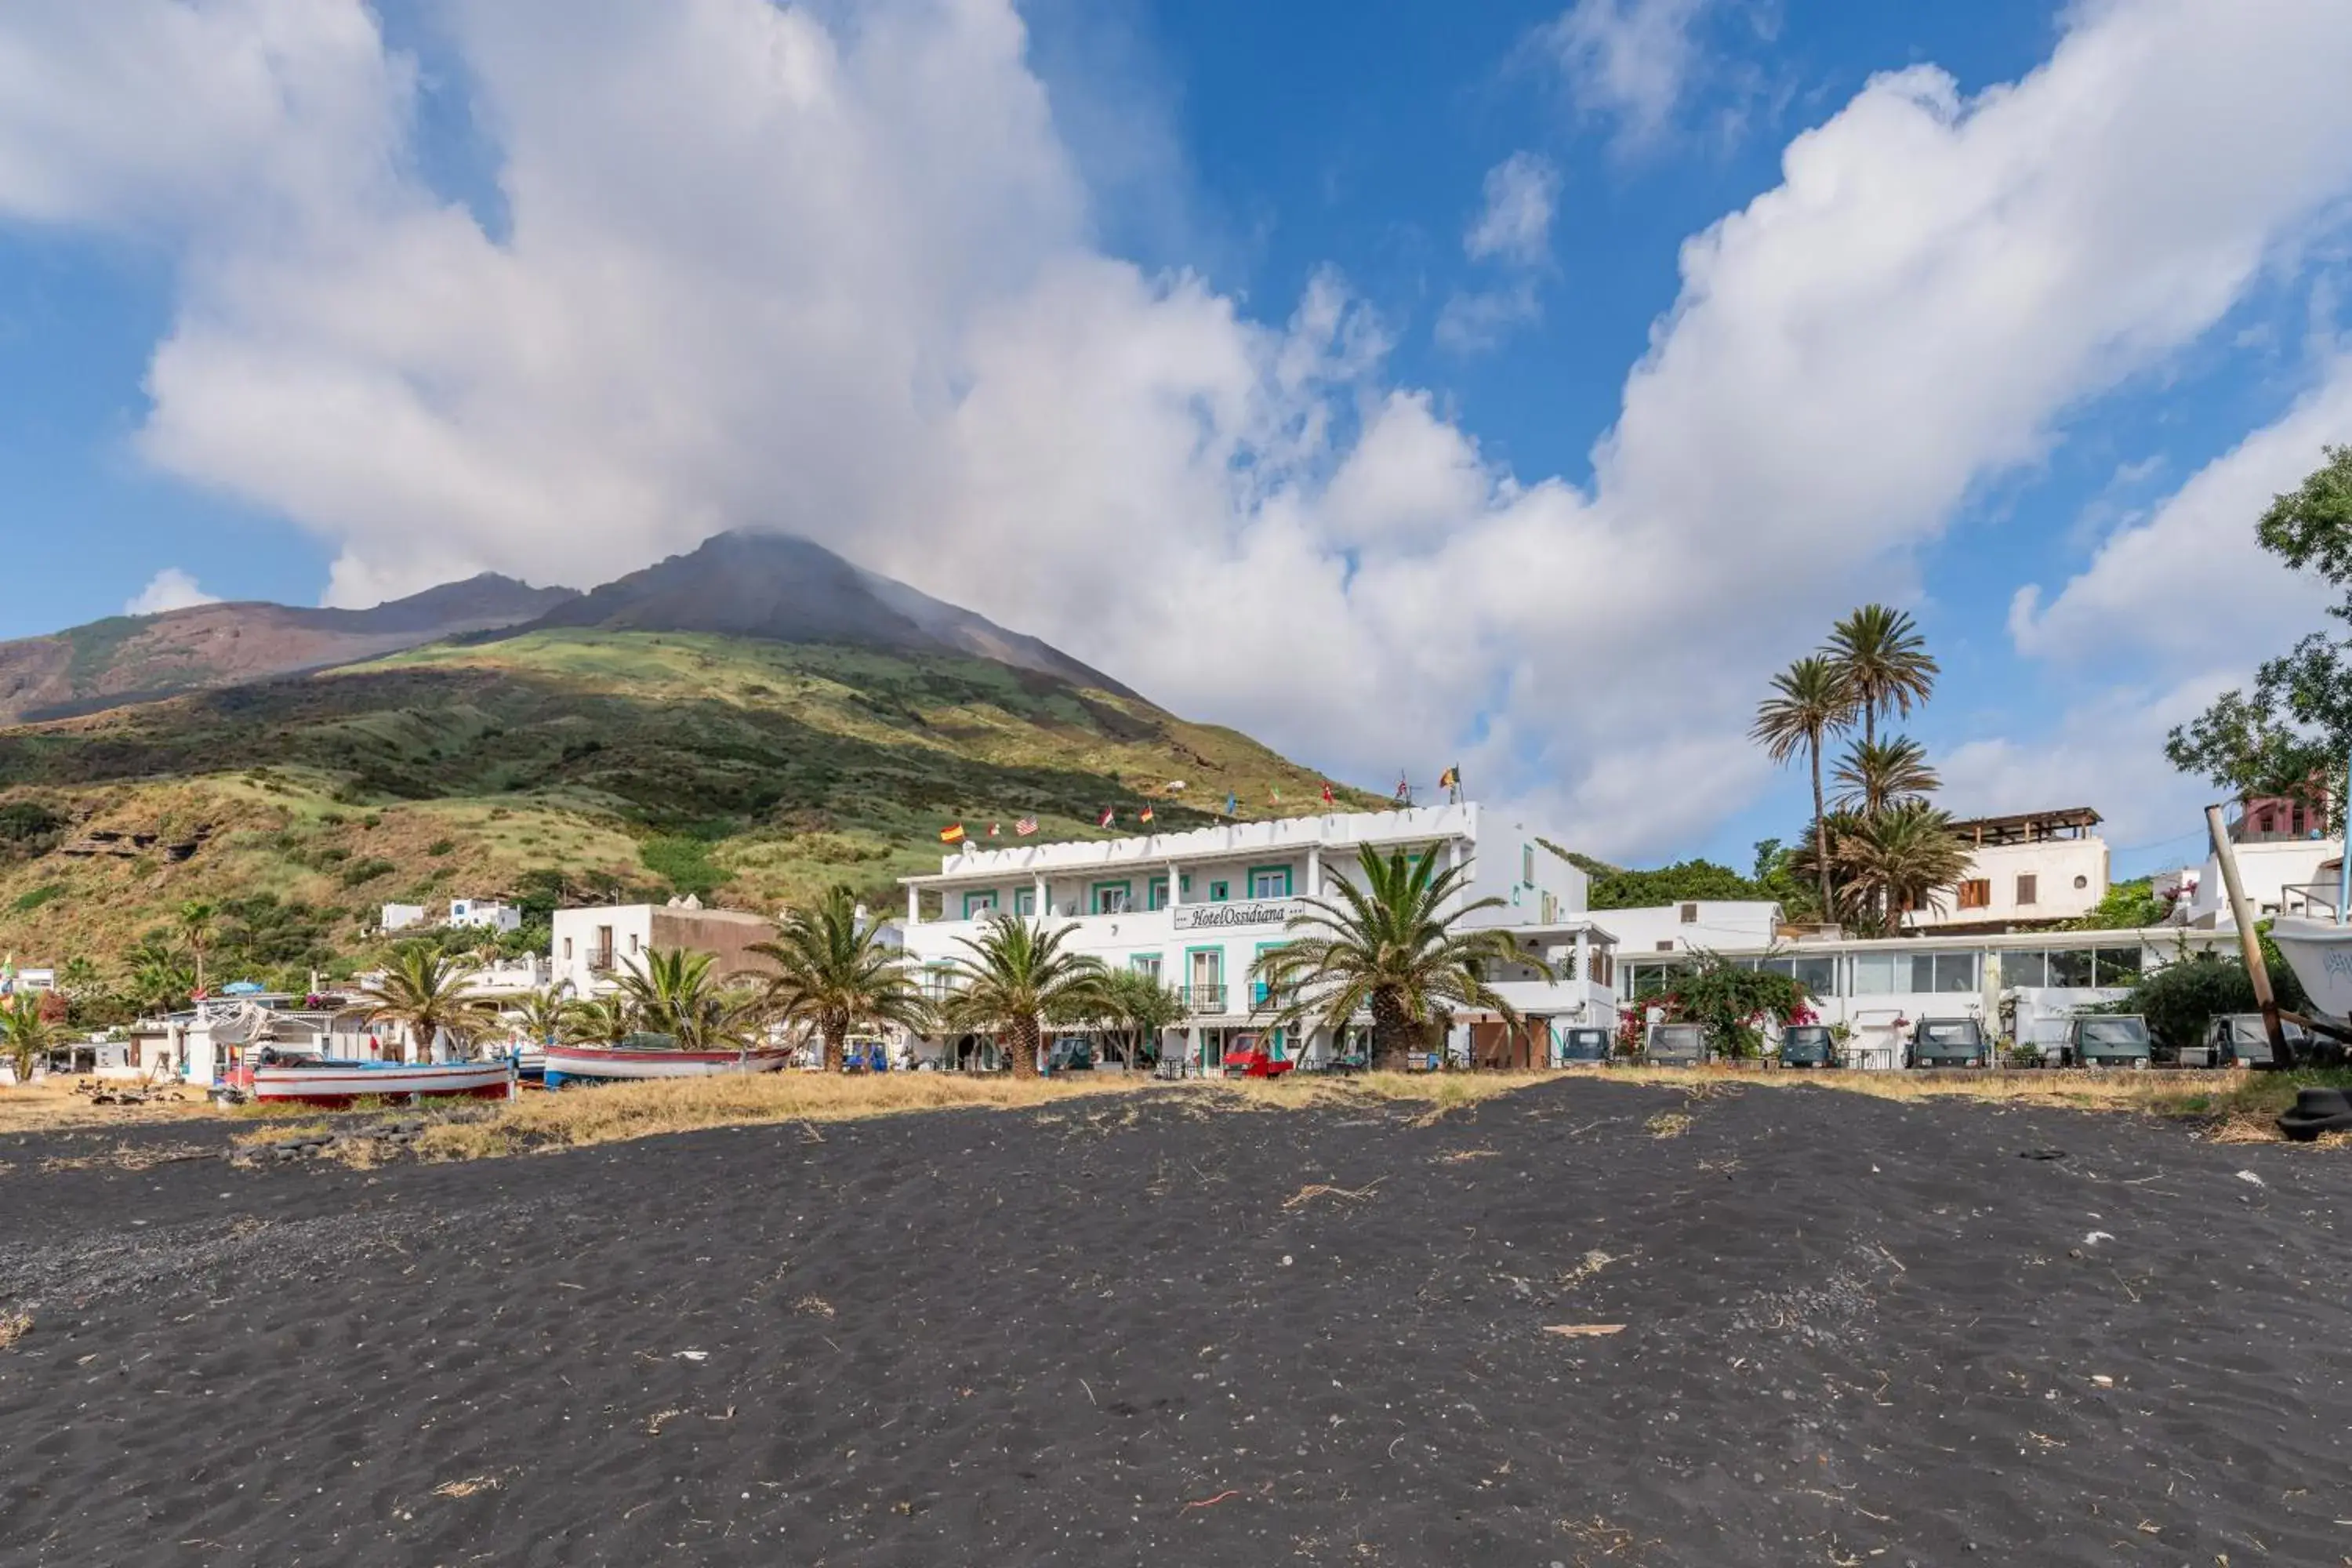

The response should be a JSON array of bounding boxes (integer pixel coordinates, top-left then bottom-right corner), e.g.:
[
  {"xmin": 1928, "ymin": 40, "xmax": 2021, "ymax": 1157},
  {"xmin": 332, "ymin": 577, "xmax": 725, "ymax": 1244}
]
[{"xmin": 903, "ymin": 804, "xmax": 1616, "ymax": 1069}]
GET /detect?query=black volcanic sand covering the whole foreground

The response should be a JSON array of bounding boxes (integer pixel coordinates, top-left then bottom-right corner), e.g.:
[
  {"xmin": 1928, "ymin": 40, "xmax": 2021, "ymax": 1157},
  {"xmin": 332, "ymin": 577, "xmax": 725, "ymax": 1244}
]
[{"xmin": 0, "ymin": 1081, "xmax": 2352, "ymax": 1568}]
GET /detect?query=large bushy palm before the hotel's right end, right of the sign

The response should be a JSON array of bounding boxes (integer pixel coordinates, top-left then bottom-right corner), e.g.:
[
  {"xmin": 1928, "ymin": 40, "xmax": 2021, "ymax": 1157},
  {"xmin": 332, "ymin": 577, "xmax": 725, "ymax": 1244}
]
[{"xmin": 1251, "ymin": 844, "xmax": 1552, "ymax": 1072}]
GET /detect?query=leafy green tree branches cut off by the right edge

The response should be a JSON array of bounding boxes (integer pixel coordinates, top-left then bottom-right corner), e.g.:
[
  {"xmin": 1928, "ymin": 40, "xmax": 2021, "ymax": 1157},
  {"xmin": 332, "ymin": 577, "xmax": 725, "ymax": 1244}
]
[{"xmin": 2164, "ymin": 447, "xmax": 2352, "ymax": 806}]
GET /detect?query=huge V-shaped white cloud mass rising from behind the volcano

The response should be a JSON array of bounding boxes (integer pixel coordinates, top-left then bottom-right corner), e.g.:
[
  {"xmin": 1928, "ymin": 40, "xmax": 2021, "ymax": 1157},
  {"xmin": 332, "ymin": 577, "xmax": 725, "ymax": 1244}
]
[{"xmin": 0, "ymin": 0, "xmax": 2352, "ymax": 855}]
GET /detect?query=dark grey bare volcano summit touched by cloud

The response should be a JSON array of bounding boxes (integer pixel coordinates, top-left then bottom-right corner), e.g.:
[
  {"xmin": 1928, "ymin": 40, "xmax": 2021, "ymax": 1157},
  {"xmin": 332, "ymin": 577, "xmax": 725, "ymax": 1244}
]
[{"xmin": 517, "ymin": 534, "xmax": 1134, "ymax": 696}]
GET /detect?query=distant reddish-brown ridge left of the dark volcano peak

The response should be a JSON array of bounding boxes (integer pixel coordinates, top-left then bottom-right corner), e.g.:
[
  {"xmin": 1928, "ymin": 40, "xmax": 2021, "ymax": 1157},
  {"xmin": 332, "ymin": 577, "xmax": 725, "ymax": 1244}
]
[{"xmin": 0, "ymin": 572, "xmax": 579, "ymax": 724}]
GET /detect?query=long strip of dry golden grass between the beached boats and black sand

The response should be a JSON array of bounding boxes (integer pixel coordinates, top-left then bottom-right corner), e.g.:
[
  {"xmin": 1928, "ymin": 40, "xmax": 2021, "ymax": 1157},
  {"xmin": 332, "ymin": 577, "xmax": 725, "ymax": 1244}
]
[{"xmin": 416, "ymin": 1072, "xmax": 1150, "ymax": 1159}]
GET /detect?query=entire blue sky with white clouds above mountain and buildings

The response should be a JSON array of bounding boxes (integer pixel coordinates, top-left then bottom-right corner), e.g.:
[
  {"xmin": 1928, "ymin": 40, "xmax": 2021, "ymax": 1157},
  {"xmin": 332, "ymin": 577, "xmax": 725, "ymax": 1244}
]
[{"xmin": 0, "ymin": 0, "xmax": 2352, "ymax": 869}]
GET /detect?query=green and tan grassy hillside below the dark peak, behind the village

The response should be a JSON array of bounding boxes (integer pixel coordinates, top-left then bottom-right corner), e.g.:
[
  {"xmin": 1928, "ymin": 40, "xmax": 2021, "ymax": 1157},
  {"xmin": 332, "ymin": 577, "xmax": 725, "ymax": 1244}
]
[{"xmin": 0, "ymin": 630, "xmax": 1381, "ymax": 982}]
